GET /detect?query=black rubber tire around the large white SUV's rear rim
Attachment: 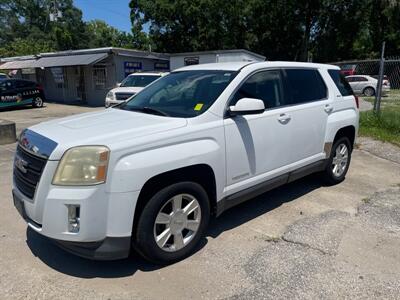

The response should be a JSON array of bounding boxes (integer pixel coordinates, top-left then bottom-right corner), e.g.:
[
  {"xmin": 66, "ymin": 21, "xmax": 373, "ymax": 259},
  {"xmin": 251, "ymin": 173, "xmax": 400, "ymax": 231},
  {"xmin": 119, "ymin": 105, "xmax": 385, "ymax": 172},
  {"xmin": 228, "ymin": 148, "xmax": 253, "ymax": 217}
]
[{"xmin": 323, "ymin": 137, "xmax": 353, "ymax": 185}]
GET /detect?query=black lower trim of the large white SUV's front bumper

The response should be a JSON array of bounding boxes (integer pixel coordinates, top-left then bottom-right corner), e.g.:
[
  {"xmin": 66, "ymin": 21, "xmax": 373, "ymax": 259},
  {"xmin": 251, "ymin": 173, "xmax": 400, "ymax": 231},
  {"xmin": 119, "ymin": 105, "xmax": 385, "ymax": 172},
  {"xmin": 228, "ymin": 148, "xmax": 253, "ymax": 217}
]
[{"xmin": 13, "ymin": 190, "xmax": 131, "ymax": 260}]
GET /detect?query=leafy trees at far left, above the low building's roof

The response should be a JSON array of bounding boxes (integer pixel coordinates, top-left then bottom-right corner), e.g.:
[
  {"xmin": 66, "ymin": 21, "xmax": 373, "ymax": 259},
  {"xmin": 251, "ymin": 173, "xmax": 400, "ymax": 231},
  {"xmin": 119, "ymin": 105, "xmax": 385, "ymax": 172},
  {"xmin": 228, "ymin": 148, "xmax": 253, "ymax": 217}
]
[{"xmin": 0, "ymin": 0, "xmax": 87, "ymax": 55}]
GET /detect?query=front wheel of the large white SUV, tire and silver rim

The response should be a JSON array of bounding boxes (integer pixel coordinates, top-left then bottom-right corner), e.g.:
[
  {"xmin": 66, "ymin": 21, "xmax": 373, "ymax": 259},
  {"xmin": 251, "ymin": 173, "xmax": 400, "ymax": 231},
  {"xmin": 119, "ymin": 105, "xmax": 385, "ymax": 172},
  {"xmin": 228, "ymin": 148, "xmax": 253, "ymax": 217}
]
[{"xmin": 133, "ymin": 182, "xmax": 210, "ymax": 264}]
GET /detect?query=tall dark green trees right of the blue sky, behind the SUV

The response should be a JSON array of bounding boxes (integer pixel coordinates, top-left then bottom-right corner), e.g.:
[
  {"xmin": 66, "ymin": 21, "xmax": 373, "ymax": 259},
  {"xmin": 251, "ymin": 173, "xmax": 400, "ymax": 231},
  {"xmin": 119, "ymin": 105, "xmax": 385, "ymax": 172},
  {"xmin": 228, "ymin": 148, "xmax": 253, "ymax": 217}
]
[{"xmin": 130, "ymin": 0, "xmax": 400, "ymax": 62}]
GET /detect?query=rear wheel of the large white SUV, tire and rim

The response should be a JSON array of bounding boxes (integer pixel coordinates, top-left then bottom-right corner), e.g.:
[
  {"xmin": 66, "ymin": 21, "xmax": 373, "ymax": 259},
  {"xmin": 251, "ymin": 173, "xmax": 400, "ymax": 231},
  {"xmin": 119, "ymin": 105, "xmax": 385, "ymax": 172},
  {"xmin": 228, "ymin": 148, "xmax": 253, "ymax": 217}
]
[{"xmin": 324, "ymin": 137, "xmax": 352, "ymax": 184}]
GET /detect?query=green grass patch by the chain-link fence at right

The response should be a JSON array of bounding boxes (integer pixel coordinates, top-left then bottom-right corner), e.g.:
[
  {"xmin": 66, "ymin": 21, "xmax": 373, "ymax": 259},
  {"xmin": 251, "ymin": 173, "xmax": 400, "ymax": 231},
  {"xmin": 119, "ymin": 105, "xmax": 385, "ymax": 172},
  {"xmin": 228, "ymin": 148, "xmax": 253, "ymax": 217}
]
[{"xmin": 359, "ymin": 90, "xmax": 400, "ymax": 146}]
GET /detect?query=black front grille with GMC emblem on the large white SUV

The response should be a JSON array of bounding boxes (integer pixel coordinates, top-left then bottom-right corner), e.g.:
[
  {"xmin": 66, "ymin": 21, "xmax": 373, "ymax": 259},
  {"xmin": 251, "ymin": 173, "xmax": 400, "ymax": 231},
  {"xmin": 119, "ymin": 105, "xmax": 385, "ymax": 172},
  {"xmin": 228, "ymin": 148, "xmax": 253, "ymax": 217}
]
[{"xmin": 14, "ymin": 145, "xmax": 47, "ymax": 199}]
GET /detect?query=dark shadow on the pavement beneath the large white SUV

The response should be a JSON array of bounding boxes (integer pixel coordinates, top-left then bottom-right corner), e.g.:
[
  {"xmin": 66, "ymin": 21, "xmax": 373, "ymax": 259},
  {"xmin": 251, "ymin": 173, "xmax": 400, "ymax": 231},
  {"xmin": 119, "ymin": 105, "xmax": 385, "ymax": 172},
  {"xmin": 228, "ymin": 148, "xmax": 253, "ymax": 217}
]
[{"xmin": 26, "ymin": 175, "xmax": 321, "ymax": 278}]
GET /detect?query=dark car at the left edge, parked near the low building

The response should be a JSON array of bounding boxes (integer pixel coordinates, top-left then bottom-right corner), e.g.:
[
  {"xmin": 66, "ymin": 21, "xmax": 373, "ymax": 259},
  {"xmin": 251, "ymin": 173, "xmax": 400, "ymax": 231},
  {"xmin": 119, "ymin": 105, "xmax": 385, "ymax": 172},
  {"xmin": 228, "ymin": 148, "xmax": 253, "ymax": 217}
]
[{"xmin": 0, "ymin": 79, "xmax": 45, "ymax": 109}]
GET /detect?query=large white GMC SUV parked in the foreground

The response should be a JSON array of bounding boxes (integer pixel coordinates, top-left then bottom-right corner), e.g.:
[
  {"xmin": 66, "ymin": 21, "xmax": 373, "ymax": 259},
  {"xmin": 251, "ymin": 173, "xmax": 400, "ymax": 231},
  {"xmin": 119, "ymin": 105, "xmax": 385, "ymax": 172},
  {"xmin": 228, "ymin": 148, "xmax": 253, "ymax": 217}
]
[{"xmin": 13, "ymin": 62, "xmax": 358, "ymax": 263}]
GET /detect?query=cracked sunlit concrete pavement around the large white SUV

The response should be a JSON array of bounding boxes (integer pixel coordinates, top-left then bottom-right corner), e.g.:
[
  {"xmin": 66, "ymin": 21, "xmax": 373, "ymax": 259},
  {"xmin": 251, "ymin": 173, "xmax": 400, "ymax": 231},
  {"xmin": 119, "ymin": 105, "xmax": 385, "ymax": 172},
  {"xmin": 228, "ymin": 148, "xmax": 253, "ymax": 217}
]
[{"xmin": 0, "ymin": 103, "xmax": 400, "ymax": 299}]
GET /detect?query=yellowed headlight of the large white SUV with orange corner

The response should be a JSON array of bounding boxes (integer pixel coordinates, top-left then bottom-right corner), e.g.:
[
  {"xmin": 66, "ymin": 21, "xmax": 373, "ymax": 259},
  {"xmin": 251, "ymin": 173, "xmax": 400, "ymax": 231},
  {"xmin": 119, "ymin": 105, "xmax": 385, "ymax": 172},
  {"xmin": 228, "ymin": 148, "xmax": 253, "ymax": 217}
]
[{"xmin": 53, "ymin": 146, "xmax": 110, "ymax": 185}]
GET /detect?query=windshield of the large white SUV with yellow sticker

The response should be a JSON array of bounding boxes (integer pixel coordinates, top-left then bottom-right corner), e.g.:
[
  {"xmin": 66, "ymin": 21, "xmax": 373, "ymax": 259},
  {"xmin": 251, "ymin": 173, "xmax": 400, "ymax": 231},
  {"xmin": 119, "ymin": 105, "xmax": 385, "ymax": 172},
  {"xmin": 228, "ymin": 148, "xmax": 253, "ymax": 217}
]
[{"xmin": 119, "ymin": 70, "xmax": 237, "ymax": 118}]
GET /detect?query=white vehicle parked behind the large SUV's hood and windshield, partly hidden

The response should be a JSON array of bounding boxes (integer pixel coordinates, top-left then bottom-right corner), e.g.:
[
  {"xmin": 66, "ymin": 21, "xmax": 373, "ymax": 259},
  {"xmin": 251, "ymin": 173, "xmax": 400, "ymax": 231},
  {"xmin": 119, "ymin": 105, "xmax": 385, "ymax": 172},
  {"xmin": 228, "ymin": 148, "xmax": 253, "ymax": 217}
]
[{"xmin": 105, "ymin": 72, "xmax": 168, "ymax": 107}]
